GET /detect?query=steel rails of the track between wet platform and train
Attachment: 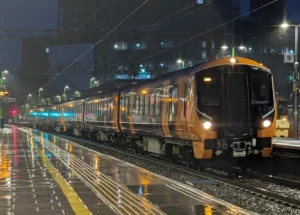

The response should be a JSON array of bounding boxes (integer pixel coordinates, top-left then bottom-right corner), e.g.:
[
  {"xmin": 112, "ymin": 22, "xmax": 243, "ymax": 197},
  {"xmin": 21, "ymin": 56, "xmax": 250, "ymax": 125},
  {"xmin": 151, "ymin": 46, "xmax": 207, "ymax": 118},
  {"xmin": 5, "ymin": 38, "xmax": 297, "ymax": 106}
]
[{"xmin": 17, "ymin": 125, "xmax": 300, "ymax": 209}]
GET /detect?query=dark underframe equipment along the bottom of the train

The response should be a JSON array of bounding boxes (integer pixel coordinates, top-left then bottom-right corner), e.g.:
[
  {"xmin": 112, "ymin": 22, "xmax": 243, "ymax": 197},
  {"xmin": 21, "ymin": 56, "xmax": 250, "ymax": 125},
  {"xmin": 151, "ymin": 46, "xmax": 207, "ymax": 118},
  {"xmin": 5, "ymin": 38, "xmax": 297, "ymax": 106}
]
[{"xmin": 32, "ymin": 125, "xmax": 272, "ymax": 167}]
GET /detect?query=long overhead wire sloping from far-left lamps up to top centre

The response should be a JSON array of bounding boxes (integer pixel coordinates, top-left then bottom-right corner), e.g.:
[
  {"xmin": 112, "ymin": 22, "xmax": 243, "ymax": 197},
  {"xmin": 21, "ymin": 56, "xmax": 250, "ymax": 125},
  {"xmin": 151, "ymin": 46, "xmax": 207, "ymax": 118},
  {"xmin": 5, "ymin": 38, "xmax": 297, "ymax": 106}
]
[{"xmin": 22, "ymin": 0, "xmax": 149, "ymax": 98}]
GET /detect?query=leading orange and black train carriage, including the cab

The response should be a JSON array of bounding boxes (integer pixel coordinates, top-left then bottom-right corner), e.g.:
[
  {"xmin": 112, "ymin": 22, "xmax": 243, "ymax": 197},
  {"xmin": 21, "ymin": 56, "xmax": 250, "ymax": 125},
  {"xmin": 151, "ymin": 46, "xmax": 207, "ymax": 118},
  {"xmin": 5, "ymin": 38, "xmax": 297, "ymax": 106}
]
[{"xmin": 119, "ymin": 58, "xmax": 275, "ymax": 159}]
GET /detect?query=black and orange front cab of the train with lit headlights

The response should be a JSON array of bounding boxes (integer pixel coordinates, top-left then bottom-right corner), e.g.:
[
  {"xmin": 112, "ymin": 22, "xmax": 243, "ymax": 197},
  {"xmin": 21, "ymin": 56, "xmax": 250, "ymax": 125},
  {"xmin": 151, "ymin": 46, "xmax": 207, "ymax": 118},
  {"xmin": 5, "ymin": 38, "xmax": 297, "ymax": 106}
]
[{"xmin": 186, "ymin": 58, "xmax": 276, "ymax": 159}]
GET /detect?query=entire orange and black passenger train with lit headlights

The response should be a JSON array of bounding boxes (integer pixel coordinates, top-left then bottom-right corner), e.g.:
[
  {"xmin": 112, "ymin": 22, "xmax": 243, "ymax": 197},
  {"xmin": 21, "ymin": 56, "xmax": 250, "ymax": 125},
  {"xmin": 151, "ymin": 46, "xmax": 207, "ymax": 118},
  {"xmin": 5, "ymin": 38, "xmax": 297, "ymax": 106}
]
[{"xmin": 28, "ymin": 57, "xmax": 277, "ymax": 161}]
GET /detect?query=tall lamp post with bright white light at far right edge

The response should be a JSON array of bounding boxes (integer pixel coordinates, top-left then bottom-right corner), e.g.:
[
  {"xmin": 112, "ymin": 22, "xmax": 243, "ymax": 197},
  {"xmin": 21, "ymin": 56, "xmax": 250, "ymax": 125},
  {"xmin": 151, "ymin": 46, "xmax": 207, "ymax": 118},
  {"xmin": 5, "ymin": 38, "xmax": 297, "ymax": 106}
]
[{"xmin": 281, "ymin": 23, "xmax": 300, "ymax": 139}]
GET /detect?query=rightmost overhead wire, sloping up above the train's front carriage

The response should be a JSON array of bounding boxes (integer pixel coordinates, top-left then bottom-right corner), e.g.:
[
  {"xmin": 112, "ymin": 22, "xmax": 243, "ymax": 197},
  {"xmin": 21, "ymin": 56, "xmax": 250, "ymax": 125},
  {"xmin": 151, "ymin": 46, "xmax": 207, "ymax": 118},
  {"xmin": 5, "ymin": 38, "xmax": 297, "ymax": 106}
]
[{"xmin": 139, "ymin": 0, "xmax": 278, "ymax": 62}]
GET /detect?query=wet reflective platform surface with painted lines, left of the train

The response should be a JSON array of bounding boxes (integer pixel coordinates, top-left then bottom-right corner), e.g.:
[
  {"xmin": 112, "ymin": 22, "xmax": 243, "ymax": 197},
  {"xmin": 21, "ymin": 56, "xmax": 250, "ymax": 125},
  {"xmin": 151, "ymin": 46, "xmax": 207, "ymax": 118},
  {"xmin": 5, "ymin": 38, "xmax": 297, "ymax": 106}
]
[{"xmin": 0, "ymin": 127, "xmax": 255, "ymax": 215}]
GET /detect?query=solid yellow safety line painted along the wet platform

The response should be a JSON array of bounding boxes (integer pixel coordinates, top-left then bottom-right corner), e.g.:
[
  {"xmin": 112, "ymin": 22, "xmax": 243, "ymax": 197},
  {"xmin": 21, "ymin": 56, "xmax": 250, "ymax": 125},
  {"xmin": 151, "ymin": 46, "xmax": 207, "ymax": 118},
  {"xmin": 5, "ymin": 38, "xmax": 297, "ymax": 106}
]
[{"xmin": 32, "ymin": 139, "xmax": 92, "ymax": 215}]
